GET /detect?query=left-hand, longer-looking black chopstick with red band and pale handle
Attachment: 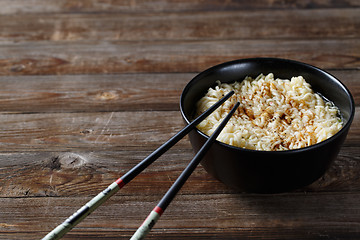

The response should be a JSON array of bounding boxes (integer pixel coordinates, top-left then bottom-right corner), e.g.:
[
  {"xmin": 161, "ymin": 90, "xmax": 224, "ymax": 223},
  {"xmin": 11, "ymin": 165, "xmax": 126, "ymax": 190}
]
[{"xmin": 42, "ymin": 91, "xmax": 234, "ymax": 240}]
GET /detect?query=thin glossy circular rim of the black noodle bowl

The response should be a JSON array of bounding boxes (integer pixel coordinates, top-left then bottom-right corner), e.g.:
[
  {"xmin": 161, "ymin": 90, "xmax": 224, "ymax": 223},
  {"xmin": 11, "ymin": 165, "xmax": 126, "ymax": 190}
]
[{"xmin": 180, "ymin": 57, "xmax": 355, "ymax": 155}]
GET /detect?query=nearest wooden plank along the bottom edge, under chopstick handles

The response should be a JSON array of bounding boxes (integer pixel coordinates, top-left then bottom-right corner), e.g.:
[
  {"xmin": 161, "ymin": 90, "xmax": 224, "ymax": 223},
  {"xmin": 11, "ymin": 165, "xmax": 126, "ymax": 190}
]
[{"xmin": 0, "ymin": 193, "xmax": 360, "ymax": 239}]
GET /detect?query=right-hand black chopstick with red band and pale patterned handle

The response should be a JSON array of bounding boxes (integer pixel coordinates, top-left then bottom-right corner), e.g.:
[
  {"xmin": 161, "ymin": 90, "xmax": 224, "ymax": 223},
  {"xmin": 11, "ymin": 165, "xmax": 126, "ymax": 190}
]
[{"xmin": 130, "ymin": 102, "xmax": 240, "ymax": 240}]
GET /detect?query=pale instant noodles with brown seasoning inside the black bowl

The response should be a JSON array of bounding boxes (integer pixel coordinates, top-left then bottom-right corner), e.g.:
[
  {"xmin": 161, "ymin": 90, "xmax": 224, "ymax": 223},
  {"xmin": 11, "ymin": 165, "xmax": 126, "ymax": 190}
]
[{"xmin": 196, "ymin": 73, "xmax": 343, "ymax": 151}]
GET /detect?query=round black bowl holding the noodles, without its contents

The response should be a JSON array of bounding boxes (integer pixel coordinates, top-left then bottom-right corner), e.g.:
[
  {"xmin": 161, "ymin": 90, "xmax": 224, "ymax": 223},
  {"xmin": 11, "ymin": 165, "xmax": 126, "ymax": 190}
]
[{"xmin": 180, "ymin": 58, "xmax": 355, "ymax": 193}]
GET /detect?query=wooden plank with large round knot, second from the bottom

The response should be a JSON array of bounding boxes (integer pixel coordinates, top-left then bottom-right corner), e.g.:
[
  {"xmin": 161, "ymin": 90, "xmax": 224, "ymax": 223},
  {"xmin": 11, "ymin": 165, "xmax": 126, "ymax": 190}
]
[{"xmin": 0, "ymin": 141, "xmax": 360, "ymax": 197}]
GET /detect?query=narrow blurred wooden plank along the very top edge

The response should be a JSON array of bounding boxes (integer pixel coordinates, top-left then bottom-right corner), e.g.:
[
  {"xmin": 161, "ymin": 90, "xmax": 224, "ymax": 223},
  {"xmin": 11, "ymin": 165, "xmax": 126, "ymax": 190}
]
[{"xmin": 0, "ymin": 0, "xmax": 360, "ymax": 14}]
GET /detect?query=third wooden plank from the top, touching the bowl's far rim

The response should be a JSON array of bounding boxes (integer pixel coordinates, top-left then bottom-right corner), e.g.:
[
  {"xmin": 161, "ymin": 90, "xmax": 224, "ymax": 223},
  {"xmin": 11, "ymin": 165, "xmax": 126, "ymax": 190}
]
[{"xmin": 0, "ymin": 39, "xmax": 360, "ymax": 76}]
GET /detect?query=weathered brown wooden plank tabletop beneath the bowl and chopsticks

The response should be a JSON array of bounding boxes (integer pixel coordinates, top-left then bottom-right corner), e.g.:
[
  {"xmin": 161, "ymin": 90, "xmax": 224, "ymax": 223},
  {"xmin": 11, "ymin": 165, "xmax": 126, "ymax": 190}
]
[{"xmin": 0, "ymin": 0, "xmax": 360, "ymax": 239}]
